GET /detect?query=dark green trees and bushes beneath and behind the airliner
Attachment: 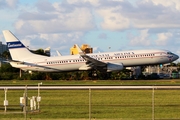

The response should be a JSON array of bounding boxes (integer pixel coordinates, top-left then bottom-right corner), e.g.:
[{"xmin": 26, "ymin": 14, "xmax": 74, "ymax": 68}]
[{"xmin": 0, "ymin": 63, "xmax": 180, "ymax": 80}]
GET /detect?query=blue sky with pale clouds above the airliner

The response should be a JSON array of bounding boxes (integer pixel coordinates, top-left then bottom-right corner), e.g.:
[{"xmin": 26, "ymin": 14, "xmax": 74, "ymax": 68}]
[{"xmin": 0, "ymin": 0, "xmax": 180, "ymax": 60}]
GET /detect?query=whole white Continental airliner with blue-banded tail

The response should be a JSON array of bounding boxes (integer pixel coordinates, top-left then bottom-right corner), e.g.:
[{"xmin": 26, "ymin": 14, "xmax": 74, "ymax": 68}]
[{"xmin": 3, "ymin": 30, "xmax": 179, "ymax": 72}]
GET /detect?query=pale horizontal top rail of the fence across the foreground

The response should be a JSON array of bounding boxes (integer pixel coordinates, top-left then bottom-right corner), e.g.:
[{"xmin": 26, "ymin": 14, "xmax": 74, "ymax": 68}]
[{"xmin": 0, "ymin": 85, "xmax": 180, "ymax": 90}]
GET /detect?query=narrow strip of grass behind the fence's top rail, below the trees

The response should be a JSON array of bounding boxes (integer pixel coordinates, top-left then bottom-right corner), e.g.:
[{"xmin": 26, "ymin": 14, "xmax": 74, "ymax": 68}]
[{"xmin": 0, "ymin": 79, "xmax": 180, "ymax": 85}]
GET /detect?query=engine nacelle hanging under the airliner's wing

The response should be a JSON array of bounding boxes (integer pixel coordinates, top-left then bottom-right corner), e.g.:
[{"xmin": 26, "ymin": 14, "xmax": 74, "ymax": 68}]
[{"xmin": 107, "ymin": 63, "xmax": 124, "ymax": 72}]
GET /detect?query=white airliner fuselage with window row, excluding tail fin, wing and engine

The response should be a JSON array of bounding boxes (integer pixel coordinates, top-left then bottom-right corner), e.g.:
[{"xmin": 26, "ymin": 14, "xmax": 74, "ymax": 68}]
[{"xmin": 10, "ymin": 50, "xmax": 179, "ymax": 72}]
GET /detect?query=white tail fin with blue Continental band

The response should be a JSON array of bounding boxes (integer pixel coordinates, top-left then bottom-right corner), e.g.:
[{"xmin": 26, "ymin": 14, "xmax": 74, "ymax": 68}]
[{"xmin": 3, "ymin": 30, "xmax": 41, "ymax": 61}]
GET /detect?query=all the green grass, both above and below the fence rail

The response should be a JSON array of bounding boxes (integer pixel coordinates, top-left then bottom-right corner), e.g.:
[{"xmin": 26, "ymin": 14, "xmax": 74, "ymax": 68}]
[{"xmin": 0, "ymin": 80, "xmax": 180, "ymax": 120}]
